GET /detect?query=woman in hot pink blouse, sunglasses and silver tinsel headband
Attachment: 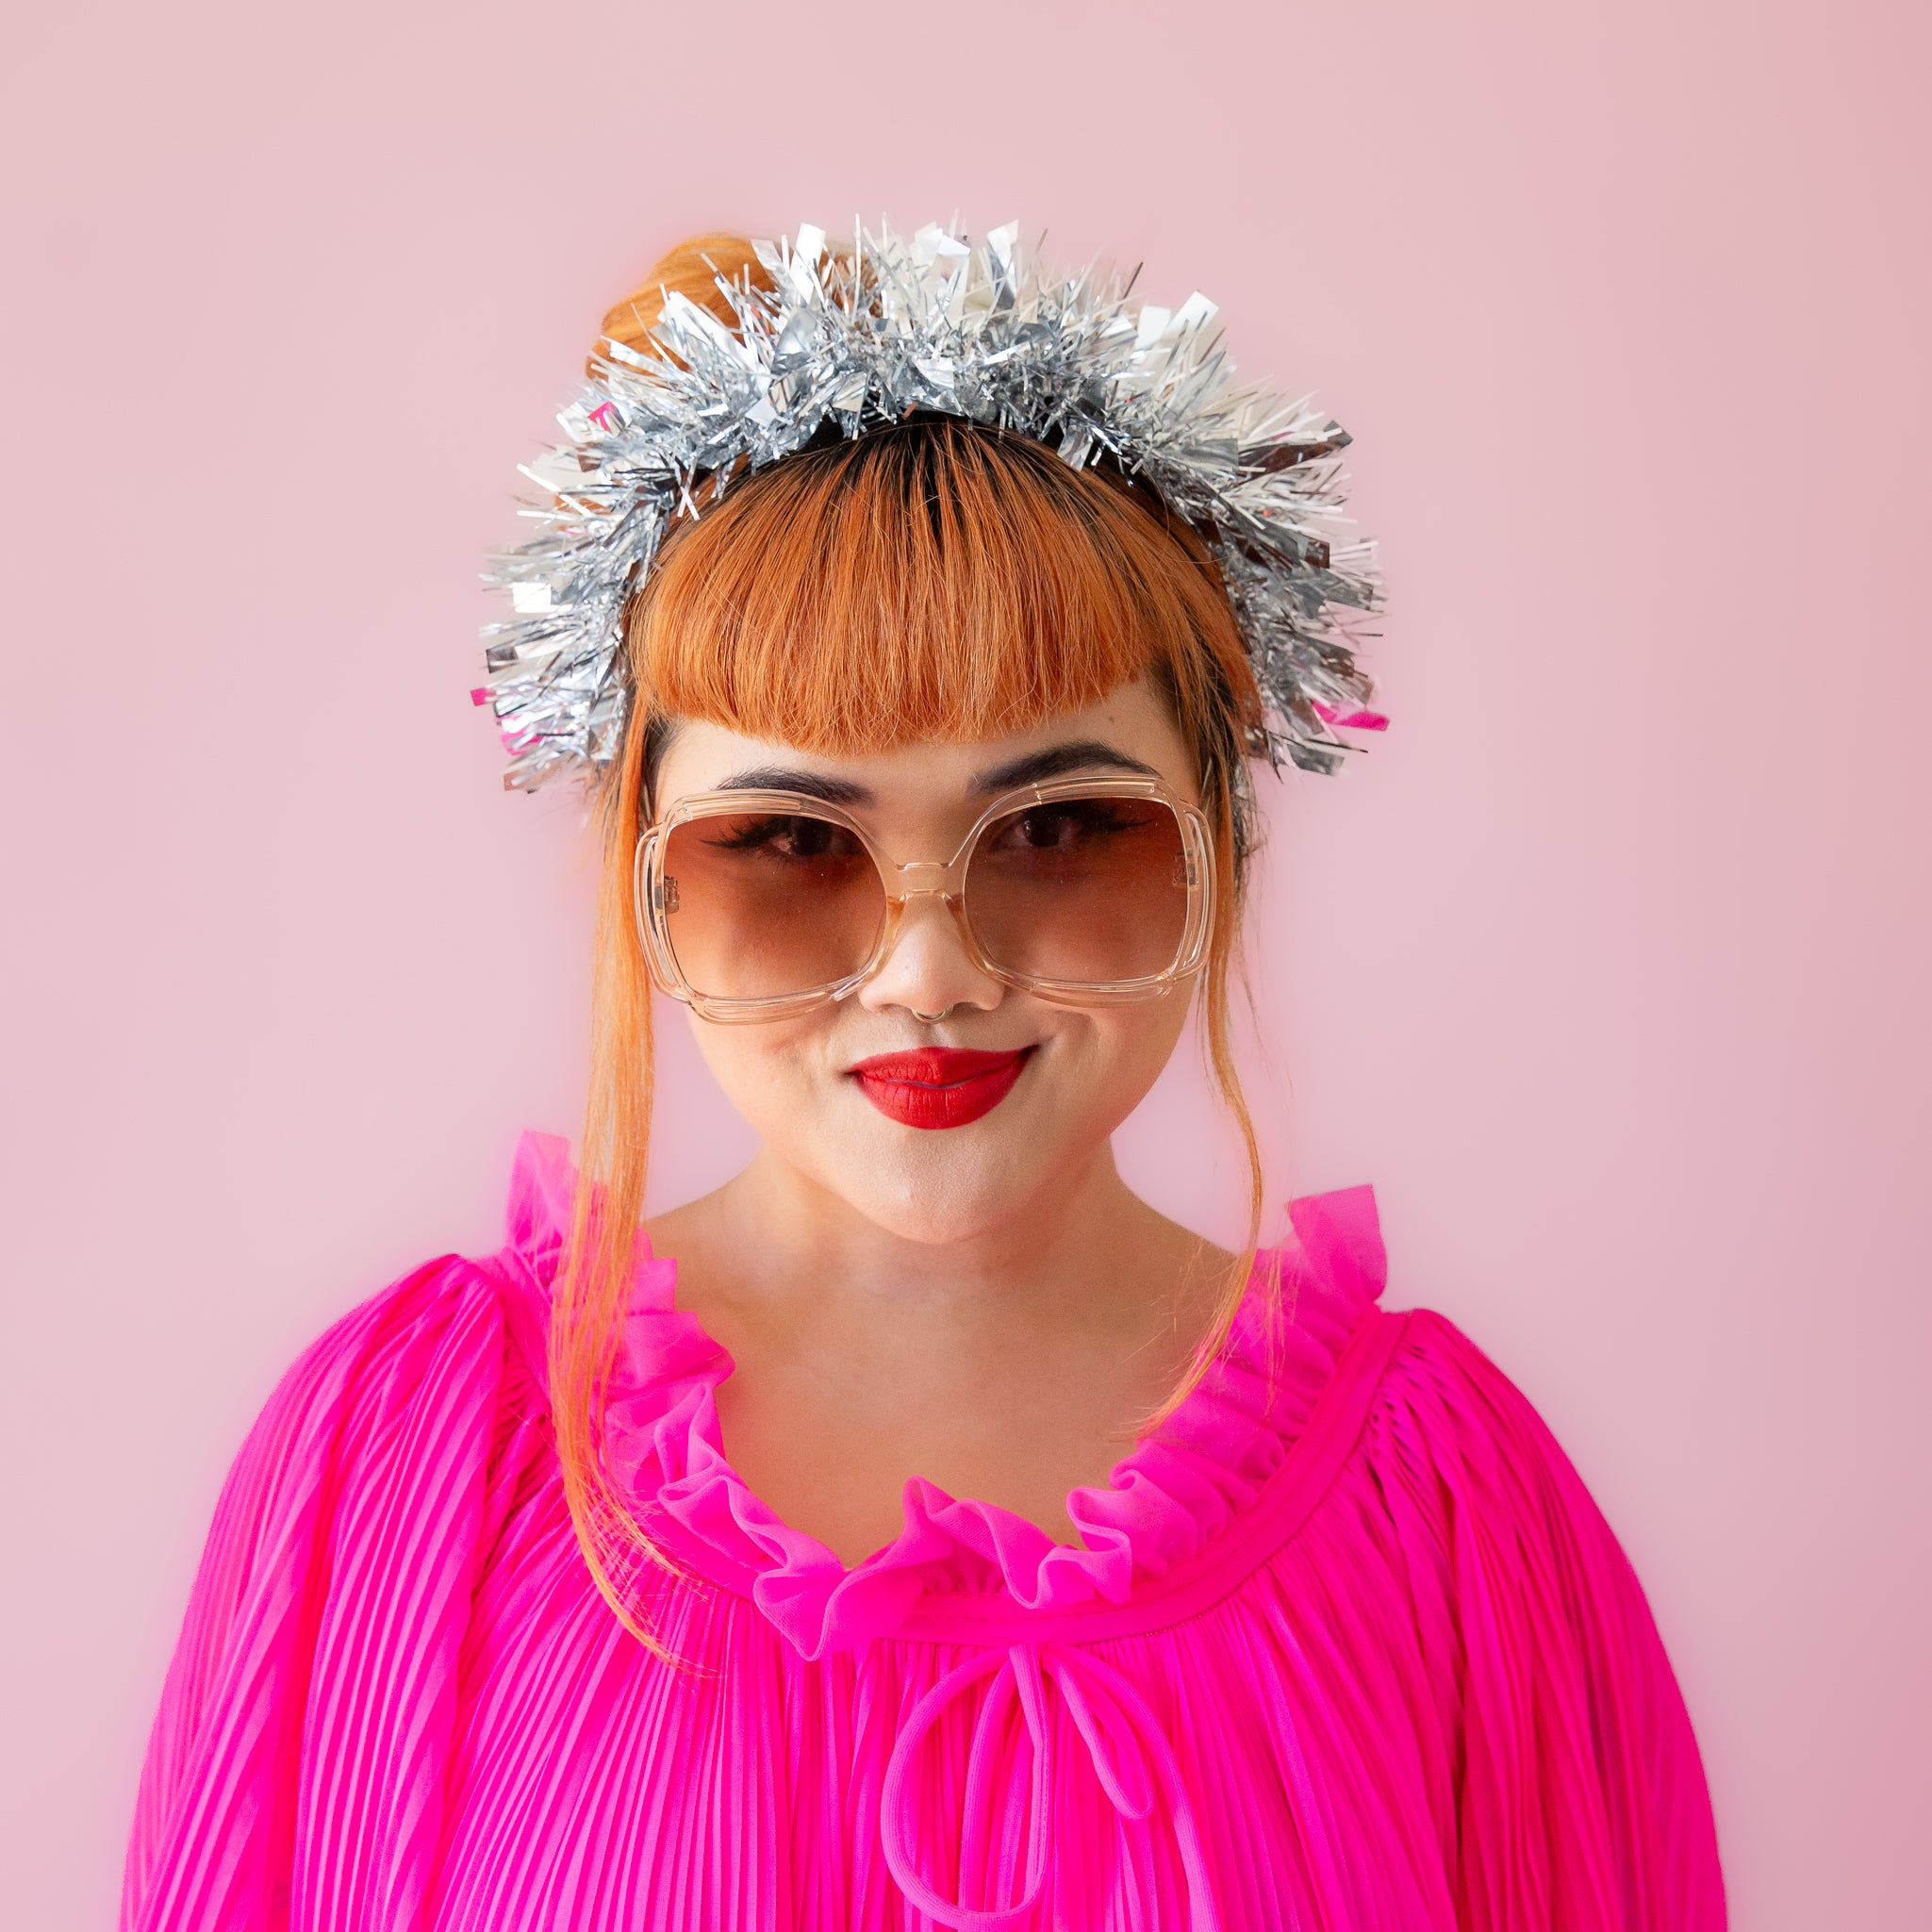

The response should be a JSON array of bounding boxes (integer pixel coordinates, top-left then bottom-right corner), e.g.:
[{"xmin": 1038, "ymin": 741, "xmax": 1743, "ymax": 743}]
[{"xmin": 125, "ymin": 230, "xmax": 1724, "ymax": 1932}]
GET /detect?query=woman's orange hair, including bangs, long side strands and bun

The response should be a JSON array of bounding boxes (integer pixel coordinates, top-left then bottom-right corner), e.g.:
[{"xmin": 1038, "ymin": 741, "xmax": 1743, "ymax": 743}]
[{"xmin": 551, "ymin": 236, "xmax": 1262, "ymax": 1648}]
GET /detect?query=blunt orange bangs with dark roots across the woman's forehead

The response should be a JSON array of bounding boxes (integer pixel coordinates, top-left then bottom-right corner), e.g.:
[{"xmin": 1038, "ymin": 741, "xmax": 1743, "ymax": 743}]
[{"xmin": 630, "ymin": 418, "xmax": 1247, "ymax": 757}]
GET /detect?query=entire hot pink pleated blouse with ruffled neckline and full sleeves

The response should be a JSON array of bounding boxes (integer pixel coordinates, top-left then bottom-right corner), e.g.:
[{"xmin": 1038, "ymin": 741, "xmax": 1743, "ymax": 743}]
[{"xmin": 122, "ymin": 1136, "xmax": 1724, "ymax": 1932}]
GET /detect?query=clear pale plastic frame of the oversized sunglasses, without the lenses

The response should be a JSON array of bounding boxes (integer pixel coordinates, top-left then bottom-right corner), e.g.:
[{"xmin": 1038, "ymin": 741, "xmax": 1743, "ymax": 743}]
[{"xmin": 632, "ymin": 777, "xmax": 1214, "ymax": 1024}]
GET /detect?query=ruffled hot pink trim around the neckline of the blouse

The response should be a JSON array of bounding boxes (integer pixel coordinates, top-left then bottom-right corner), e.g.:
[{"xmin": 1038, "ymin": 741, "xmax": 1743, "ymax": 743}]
[{"xmin": 490, "ymin": 1134, "xmax": 1387, "ymax": 1658}]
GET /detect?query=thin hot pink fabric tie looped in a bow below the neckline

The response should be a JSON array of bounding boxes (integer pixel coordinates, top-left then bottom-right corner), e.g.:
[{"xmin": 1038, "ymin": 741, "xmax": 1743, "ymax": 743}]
[{"xmin": 879, "ymin": 1643, "xmax": 1221, "ymax": 1932}]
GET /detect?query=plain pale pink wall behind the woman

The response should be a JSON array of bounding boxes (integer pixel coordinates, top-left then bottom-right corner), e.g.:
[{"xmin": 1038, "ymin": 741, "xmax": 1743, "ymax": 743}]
[{"xmin": 0, "ymin": 0, "xmax": 1932, "ymax": 1932}]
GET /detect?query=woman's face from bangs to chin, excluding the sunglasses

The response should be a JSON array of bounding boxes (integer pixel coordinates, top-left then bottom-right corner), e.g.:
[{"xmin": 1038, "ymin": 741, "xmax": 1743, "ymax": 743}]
[{"xmin": 655, "ymin": 680, "xmax": 1197, "ymax": 1245}]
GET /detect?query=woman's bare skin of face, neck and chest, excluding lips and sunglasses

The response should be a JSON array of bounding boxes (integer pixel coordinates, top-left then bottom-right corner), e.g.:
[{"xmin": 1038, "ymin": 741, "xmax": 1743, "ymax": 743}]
[{"xmin": 649, "ymin": 684, "xmax": 1232, "ymax": 1565}]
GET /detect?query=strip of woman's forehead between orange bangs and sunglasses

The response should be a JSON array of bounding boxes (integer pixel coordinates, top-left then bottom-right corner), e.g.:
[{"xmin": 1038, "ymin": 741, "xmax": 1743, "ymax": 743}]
[{"xmin": 655, "ymin": 680, "xmax": 1196, "ymax": 812}]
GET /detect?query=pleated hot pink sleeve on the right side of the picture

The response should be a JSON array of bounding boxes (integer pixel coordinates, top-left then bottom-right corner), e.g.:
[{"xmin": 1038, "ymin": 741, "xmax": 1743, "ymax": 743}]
[{"xmin": 1368, "ymin": 1313, "xmax": 1724, "ymax": 1932}]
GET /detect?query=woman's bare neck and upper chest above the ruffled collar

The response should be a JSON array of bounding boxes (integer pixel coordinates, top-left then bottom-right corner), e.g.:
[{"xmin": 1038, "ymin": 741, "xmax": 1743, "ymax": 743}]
[{"xmin": 652, "ymin": 1144, "xmax": 1232, "ymax": 1563}]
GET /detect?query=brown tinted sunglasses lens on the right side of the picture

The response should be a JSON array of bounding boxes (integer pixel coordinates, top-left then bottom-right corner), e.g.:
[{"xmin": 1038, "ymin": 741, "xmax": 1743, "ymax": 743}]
[{"xmin": 966, "ymin": 798, "xmax": 1188, "ymax": 985}]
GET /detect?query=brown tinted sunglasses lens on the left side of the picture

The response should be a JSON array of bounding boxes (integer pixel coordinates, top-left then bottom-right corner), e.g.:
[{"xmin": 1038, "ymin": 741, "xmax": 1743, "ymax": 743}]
[{"xmin": 665, "ymin": 812, "xmax": 884, "ymax": 999}]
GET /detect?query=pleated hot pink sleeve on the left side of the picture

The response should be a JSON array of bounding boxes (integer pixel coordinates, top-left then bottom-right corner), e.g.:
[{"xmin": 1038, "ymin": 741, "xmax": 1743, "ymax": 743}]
[{"xmin": 122, "ymin": 1260, "xmax": 533, "ymax": 1932}]
